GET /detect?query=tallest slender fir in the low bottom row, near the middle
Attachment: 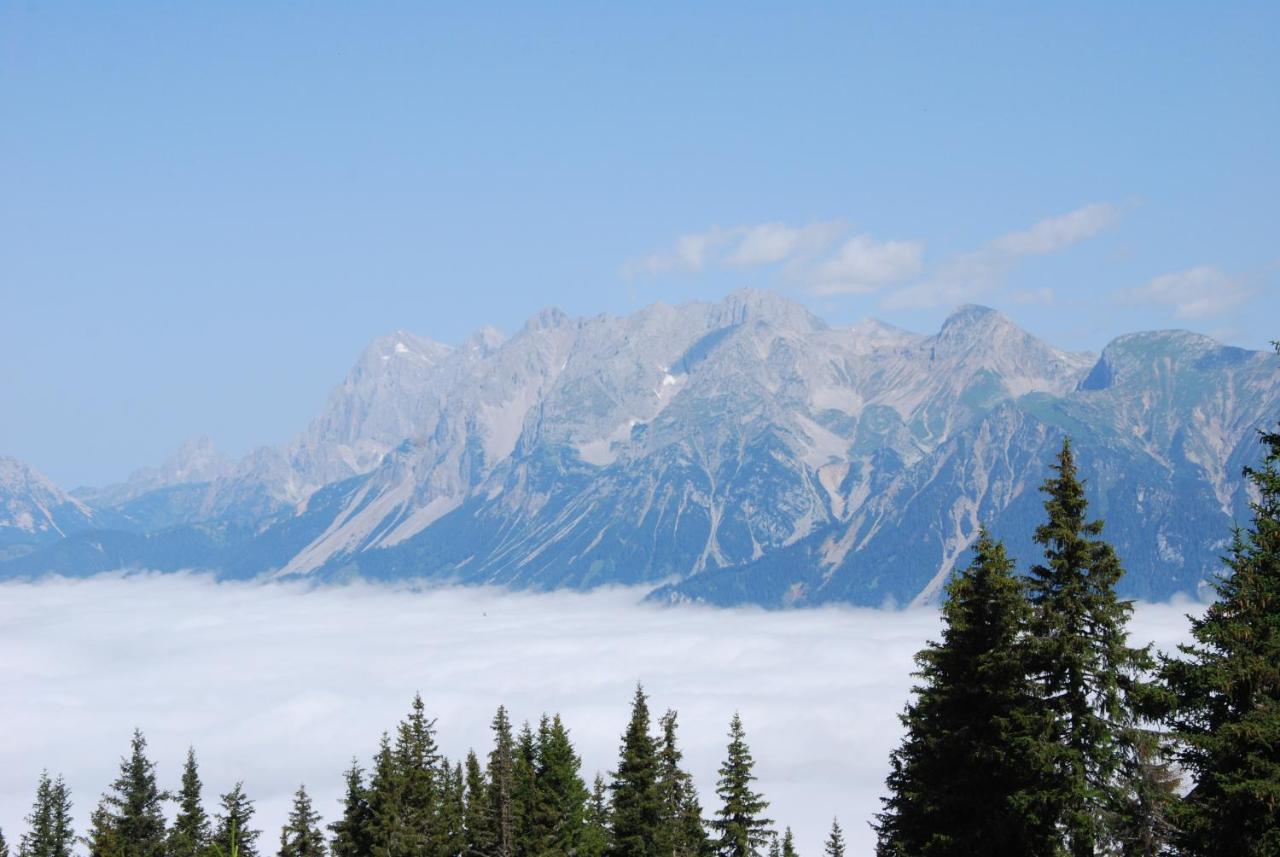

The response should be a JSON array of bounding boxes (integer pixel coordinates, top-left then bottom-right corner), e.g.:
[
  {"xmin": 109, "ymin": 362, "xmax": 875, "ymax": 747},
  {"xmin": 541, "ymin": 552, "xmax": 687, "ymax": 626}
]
[{"xmin": 608, "ymin": 684, "xmax": 662, "ymax": 857}]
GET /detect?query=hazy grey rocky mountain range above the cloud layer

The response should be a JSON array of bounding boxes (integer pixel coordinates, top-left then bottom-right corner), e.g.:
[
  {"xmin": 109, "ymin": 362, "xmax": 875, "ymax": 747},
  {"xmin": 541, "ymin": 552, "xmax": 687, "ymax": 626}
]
[{"xmin": 0, "ymin": 292, "xmax": 1280, "ymax": 605}]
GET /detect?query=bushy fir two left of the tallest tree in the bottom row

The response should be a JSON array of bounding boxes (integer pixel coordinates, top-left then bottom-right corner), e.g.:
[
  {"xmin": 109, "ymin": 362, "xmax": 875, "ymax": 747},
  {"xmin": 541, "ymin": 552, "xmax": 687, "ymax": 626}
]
[{"xmin": 531, "ymin": 714, "xmax": 589, "ymax": 857}]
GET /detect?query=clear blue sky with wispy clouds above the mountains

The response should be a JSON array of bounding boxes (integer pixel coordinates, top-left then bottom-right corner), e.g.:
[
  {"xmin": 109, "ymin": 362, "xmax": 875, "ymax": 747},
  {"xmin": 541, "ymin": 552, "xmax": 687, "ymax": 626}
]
[{"xmin": 0, "ymin": 1, "xmax": 1280, "ymax": 486}]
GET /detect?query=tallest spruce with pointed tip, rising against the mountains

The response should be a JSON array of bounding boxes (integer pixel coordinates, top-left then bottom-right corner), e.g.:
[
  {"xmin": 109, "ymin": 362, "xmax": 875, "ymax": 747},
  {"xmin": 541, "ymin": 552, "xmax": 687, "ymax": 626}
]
[{"xmin": 1029, "ymin": 440, "xmax": 1153, "ymax": 857}]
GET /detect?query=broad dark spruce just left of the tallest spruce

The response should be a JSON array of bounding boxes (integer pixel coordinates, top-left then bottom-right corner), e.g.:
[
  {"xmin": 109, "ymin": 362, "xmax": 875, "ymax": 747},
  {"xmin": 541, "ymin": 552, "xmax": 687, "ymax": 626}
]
[{"xmin": 876, "ymin": 530, "xmax": 1059, "ymax": 857}]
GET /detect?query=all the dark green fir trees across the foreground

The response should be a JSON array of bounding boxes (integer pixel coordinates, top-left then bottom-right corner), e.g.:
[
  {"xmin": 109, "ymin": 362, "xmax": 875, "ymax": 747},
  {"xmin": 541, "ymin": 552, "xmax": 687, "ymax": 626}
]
[{"xmin": 0, "ymin": 414, "xmax": 1280, "ymax": 857}]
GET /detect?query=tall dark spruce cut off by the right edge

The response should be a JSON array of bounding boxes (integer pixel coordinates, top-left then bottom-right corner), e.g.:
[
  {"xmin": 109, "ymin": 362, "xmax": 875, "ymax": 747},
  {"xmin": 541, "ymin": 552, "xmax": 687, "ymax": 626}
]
[{"xmin": 1162, "ymin": 411, "xmax": 1280, "ymax": 857}]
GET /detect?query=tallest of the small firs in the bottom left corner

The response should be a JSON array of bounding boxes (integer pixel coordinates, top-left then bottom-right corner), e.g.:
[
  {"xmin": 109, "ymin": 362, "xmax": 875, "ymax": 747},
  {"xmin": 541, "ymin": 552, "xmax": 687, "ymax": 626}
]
[{"xmin": 88, "ymin": 729, "xmax": 166, "ymax": 857}]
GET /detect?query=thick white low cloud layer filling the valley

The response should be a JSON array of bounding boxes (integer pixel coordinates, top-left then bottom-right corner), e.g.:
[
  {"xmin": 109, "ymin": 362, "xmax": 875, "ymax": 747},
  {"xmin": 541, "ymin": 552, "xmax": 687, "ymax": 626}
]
[{"xmin": 0, "ymin": 576, "xmax": 1190, "ymax": 857}]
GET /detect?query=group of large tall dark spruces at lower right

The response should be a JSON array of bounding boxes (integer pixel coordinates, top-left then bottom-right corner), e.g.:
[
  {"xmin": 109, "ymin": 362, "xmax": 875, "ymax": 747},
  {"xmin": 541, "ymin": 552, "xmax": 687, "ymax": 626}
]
[{"xmin": 873, "ymin": 419, "xmax": 1280, "ymax": 857}]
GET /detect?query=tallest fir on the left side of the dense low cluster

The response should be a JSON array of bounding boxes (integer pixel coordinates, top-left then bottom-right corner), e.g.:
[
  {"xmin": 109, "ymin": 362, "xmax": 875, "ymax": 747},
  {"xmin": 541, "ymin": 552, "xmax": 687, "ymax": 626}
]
[{"xmin": 392, "ymin": 695, "xmax": 440, "ymax": 857}]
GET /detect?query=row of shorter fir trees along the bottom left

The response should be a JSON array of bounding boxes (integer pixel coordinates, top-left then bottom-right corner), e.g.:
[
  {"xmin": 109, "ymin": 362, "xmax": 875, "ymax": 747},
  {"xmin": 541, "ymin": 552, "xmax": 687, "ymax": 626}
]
[{"xmin": 0, "ymin": 686, "xmax": 845, "ymax": 857}]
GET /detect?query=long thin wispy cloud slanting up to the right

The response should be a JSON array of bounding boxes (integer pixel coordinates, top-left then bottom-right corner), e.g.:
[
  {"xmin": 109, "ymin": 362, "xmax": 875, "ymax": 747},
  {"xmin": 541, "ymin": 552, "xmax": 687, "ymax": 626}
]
[{"xmin": 881, "ymin": 202, "xmax": 1120, "ymax": 310}]
